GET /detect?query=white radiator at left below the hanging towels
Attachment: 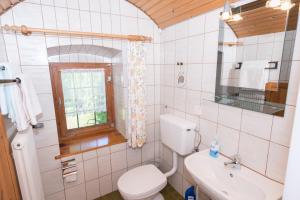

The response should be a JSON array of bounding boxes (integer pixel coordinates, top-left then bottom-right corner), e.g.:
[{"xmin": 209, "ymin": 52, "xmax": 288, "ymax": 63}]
[{"xmin": 11, "ymin": 128, "xmax": 45, "ymax": 200}]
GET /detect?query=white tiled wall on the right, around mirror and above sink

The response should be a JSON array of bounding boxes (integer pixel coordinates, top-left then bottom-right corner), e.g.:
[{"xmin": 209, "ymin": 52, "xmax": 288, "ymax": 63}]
[{"xmin": 160, "ymin": 6, "xmax": 300, "ymax": 199}]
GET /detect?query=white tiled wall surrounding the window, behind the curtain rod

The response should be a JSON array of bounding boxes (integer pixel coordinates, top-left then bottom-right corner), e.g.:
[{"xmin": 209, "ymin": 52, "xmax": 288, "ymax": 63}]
[{"xmin": 1, "ymin": 0, "xmax": 160, "ymax": 200}]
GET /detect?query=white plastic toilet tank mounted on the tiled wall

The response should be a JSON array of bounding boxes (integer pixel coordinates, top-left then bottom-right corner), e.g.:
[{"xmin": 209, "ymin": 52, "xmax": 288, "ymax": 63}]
[{"xmin": 160, "ymin": 114, "xmax": 196, "ymax": 156}]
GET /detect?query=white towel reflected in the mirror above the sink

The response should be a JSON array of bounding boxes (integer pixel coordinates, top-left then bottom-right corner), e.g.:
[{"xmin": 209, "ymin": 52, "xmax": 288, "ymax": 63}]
[{"xmin": 239, "ymin": 60, "xmax": 270, "ymax": 90}]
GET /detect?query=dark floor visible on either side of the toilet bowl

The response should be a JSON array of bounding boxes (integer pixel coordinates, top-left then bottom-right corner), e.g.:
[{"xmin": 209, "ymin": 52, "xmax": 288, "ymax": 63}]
[{"xmin": 96, "ymin": 184, "xmax": 183, "ymax": 200}]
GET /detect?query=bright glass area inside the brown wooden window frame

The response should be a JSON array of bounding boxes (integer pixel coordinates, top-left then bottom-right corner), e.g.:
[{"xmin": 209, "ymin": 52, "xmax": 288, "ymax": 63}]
[{"xmin": 61, "ymin": 69, "xmax": 108, "ymax": 129}]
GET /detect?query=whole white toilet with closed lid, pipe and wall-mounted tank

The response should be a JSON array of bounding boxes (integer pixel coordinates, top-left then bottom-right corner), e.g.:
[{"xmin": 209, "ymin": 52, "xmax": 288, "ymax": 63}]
[{"xmin": 118, "ymin": 114, "xmax": 196, "ymax": 200}]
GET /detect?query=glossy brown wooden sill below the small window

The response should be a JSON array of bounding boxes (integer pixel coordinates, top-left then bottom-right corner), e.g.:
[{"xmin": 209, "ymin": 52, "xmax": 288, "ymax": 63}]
[{"xmin": 55, "ymin": 131, "xmax": 127, "ymax": 159}]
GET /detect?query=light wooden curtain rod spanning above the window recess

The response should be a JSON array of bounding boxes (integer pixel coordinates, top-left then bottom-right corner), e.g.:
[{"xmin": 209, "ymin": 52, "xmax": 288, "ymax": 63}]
[{"xmin": 0, "ymin": 24, "xmax": 152, "ymax": 42}]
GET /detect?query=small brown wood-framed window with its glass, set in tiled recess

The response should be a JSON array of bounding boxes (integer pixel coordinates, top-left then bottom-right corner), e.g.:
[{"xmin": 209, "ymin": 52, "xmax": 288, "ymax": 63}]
[{"xmin": 50, "ymin": 63, "xmax": 115, "ymax": 142}]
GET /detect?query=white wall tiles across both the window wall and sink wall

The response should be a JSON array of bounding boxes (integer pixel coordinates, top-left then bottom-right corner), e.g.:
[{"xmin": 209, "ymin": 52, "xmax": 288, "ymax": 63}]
[{"xmin": 1, "ymin": 0, "xmax": 300, "ymax": 200}]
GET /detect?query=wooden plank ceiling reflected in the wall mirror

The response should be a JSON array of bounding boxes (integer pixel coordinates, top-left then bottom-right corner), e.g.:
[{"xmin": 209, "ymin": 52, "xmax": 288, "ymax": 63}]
[{"xmin": 227, "ymin": 0, "xmax": 299, "ymax": 38}]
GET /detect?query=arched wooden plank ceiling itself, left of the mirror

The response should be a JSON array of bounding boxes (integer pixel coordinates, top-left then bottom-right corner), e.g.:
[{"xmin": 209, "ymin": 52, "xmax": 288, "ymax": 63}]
[{"xmin": 128, "ymin": 0, "xmax": 236, "ymax": 28}]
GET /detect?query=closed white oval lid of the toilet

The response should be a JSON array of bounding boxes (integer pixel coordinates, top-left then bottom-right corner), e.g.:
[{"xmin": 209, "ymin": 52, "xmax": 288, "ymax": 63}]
[{"xmin": 118, "ymin": 165, "xmax": 167, "ymax": 199}]
